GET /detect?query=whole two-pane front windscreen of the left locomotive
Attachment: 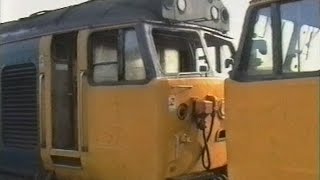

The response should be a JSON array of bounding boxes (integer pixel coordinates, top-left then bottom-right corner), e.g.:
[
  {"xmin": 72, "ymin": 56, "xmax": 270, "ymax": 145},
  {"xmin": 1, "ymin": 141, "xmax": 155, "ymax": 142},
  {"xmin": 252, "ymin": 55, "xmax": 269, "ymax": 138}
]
[{"xmin": 152, "ymin": 29, "xmax": 233, "ymax": 75}]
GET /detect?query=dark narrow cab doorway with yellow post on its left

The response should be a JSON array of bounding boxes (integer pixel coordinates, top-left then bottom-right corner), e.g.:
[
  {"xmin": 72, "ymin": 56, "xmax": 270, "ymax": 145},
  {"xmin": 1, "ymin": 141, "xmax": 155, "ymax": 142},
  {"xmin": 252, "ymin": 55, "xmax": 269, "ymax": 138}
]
[{"xmin": 39, "ymin": 32, "xmax": 81, "ymax": 167}]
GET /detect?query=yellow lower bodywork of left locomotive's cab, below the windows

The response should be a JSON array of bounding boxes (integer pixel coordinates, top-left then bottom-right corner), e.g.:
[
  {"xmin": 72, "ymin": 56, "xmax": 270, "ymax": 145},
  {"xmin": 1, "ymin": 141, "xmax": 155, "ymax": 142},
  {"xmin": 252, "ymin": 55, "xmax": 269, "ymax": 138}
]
[{"xmin": 72, "ymin": 79, "xmax": 226, "ymax": 179}]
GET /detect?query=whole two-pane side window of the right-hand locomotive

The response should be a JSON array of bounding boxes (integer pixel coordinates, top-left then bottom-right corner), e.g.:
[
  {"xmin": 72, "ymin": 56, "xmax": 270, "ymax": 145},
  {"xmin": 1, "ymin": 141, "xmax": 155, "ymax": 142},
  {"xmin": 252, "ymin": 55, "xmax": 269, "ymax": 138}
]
[{"xmin": 241, "ymin": 0, "xmax": 320, "ymax": 78}]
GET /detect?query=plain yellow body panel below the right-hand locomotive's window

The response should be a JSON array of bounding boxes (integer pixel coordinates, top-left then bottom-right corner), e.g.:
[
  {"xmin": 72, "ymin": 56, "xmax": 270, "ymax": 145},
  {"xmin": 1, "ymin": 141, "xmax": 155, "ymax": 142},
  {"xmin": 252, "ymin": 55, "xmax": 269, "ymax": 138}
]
[{"xmin": 226, "ymin": 78, "xmax": 320, "ymax": 180}]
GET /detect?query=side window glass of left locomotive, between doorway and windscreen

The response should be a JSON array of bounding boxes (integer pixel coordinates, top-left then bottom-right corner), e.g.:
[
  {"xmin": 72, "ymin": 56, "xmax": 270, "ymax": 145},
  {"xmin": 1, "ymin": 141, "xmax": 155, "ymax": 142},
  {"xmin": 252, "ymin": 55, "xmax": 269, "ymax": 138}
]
[{"xmin": 90, "ymin": 29, "xmax": 146, "ymax": 84}]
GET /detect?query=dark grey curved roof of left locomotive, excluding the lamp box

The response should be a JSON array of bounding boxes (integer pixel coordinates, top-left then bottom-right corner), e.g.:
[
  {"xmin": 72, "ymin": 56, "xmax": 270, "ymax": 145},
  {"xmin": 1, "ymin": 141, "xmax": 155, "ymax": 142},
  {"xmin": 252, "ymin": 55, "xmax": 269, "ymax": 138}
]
[{"xmin": 0, "ymin": 0, "xmax": 163, "ymax": 43}]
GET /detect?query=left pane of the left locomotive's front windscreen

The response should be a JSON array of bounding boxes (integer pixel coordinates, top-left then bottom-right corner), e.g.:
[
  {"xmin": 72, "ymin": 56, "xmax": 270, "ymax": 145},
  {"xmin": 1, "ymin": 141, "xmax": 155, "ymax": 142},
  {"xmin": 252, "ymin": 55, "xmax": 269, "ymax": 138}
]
[{"xmin": 152, "ymin": 29, "xmax": 209, "ymax": 75}]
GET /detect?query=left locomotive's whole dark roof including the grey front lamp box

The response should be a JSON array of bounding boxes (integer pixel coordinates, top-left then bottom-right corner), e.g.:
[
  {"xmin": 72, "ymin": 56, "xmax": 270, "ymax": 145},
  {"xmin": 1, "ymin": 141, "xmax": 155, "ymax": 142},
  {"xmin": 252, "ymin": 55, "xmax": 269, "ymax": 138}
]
[{"xmin": 0, "ymin": 0, "xmax": 229, "ymax": 43}]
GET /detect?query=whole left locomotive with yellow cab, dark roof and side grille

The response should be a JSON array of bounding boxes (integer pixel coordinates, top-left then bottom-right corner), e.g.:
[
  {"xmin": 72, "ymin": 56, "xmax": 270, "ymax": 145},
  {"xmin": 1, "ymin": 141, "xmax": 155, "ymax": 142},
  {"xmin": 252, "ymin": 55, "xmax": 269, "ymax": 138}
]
[{"xmin": 0, "ymin": 0, "xmax": 234, "ymax": 180}]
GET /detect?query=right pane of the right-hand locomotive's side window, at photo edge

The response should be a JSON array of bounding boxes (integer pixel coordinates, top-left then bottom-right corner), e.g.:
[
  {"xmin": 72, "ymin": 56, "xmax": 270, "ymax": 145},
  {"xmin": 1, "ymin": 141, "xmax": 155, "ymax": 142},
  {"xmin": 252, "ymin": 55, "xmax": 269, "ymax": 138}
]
[{"xmin": 280, "ymin": 0, "xmax": 320, "ymax": 73}]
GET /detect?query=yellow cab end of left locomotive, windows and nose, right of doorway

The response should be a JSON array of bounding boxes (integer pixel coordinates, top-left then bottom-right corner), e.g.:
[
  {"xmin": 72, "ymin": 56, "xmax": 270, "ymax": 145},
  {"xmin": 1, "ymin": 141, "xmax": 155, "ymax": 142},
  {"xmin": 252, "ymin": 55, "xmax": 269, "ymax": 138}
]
[{"xmin": 70, "ymin": 24, "xmax": 233, "ymax": 179}]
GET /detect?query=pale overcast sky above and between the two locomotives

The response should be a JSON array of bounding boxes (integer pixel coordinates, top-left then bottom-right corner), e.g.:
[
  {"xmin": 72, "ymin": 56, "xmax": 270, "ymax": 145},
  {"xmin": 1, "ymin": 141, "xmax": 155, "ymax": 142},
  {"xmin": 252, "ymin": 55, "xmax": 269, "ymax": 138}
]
[{"xmin": 0, "ymin": 0, "xmax": 248, "ymax": 42}]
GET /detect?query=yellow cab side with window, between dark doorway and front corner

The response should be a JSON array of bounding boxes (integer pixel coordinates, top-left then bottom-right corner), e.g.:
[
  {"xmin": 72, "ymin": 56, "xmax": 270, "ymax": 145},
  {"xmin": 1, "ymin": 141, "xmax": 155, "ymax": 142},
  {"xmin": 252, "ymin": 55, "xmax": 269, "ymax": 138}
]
[{"xmin": 77, "ymin": 25, "xmax": 162, "ymax": 179}]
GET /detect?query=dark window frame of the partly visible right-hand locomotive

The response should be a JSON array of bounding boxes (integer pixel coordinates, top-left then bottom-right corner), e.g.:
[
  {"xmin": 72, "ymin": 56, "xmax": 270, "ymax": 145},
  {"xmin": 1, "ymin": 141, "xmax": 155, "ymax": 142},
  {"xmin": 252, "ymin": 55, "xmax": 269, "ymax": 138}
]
[{"xmin": 231, "ymin": 0, "xmax": 320, "ymax": 82}]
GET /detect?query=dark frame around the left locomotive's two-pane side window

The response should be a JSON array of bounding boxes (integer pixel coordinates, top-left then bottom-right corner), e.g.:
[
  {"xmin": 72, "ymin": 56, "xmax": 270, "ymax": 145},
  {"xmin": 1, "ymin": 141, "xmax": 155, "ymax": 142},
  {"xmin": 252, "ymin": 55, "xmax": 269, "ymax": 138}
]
[{"xmin": 86, "ymin": 24, "xmax": 154, "ymax": 86}]
